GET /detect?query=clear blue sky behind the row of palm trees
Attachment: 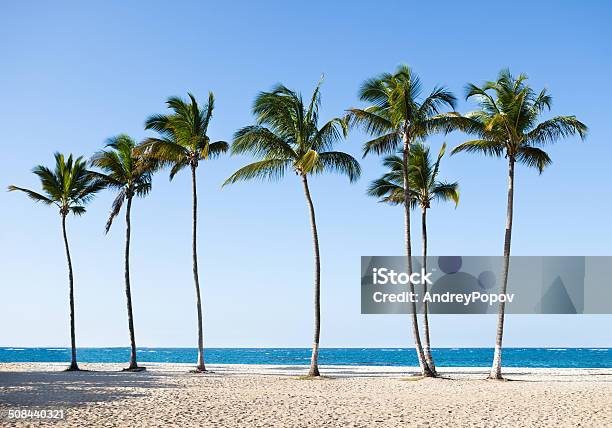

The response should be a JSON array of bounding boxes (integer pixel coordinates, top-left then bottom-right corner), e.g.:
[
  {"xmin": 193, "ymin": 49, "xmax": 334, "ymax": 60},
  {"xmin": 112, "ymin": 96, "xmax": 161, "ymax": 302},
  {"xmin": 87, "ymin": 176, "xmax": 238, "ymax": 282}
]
[{"xmin": 0, "ymin": 1, "xmax": 612, "ymax": 347}]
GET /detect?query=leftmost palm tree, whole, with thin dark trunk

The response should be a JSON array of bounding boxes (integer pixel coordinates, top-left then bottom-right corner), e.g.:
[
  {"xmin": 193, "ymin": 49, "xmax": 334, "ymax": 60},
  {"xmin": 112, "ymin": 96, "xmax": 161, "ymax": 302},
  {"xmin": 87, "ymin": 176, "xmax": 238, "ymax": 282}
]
[{"xmin": 8, "ymin": 153, "xmax": 103, "ymax": 371}]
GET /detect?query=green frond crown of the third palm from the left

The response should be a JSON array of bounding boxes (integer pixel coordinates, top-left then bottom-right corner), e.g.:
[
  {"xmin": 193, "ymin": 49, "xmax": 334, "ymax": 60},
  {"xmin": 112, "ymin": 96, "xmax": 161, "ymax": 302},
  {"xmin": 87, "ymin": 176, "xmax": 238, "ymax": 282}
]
[{"xmin": 142, "ymin": 92, "xmax": 229, "ymax": 179}]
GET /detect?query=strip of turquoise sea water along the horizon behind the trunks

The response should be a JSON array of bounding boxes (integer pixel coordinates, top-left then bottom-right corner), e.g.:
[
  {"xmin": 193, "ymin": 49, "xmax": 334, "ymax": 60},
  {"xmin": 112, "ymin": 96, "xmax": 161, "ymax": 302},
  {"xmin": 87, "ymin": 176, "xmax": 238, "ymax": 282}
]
[{"xmin": 0, "ymin": 347, "xmax": 612, "ymax": 368}]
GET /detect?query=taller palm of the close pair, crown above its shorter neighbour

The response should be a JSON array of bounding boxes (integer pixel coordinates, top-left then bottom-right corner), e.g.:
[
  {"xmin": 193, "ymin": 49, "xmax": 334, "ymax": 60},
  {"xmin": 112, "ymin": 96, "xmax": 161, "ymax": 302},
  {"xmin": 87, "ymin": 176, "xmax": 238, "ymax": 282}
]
[{"xmin": 347, "ymin": 65, "xmax": 460, "ymax": 376}]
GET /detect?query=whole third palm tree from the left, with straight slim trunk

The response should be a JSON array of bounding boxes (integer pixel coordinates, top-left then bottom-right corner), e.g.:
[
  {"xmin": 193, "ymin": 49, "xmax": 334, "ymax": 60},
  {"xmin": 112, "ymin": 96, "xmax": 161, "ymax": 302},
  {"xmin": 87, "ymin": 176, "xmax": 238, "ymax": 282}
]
[{"xmin": 141, "ymin": 92, "xmax": 229, "ymax": 372}]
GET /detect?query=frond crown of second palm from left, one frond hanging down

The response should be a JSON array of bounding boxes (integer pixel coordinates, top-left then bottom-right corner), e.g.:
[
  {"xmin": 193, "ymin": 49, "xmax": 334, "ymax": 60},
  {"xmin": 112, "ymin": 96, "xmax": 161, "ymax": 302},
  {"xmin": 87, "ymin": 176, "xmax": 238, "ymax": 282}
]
[{"xmin": 91, "ymin": 134, "xmax": 160, "ymax": 232}]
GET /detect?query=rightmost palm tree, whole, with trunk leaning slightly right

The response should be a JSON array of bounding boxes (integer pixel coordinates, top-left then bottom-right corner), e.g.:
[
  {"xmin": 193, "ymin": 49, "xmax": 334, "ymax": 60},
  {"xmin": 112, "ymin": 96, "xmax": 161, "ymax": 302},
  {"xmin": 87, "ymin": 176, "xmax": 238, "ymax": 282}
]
[{"xmin": 452, "ymin": 69, "xmax": 587, "ymax": 379}]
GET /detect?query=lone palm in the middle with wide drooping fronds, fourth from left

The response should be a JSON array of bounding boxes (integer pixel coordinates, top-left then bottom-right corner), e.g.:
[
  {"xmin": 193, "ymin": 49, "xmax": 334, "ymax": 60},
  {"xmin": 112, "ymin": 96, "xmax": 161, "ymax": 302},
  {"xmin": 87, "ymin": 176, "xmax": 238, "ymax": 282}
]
[{"xmin": 224, "ymin": 81, "xmax": 361, "ymax": 376}]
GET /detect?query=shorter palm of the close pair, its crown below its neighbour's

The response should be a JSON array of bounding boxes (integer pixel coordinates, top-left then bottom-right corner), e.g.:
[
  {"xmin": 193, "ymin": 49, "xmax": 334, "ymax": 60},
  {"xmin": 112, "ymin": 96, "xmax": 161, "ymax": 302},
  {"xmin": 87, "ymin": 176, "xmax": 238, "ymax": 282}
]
[{"xmin": 368, "ymin": 143, "xmax": 459, "ymax": 375}]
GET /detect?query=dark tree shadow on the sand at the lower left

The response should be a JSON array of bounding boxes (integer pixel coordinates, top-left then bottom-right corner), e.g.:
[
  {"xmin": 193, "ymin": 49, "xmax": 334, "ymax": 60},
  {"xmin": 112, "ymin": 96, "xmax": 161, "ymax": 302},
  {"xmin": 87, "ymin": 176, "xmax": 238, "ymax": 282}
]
[{"xmin": 0, "ymin": 372, "xmax": 175, "ymax": 407}]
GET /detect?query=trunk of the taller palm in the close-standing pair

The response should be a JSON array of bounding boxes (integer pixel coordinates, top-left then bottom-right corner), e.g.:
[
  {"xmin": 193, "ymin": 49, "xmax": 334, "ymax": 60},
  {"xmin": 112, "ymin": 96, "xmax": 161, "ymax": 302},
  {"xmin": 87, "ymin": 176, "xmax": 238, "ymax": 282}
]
[{"xmin": 402, "ymin": 132, "xmax": 432, "ymax": 377}]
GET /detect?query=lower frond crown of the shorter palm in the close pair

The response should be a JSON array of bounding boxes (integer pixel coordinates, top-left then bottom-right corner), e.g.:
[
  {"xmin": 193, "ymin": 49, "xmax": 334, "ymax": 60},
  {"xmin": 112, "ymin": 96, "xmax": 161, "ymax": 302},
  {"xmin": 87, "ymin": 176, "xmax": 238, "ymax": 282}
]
[{"xmin": 368, "ymin": 143, "xmax": 459, "ymax": 209}]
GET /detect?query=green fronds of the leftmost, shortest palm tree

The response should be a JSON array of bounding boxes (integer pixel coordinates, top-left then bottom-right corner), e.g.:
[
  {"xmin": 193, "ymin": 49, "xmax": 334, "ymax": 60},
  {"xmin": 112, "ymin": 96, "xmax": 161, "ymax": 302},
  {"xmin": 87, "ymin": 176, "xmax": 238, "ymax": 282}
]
[{"xmin": 8, "ymin": 153, "xmax": 104, "ymax": 216}]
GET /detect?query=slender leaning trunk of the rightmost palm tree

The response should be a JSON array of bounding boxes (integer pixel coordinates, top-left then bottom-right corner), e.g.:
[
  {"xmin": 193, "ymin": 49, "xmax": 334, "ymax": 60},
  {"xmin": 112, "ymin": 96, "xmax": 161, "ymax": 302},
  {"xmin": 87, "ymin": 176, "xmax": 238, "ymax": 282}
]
[{"xmin": 489, "ymin": 156, "xmax": 515, "ymax": 379}]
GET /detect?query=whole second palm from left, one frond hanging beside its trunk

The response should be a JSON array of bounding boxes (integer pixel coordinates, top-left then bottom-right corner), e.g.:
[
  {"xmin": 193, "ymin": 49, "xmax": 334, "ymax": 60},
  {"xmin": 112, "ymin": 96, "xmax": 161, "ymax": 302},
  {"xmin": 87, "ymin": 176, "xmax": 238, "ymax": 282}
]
[{"xmin": 91, "ymin": 134, "xmax": 157, "ymax": 371}]
